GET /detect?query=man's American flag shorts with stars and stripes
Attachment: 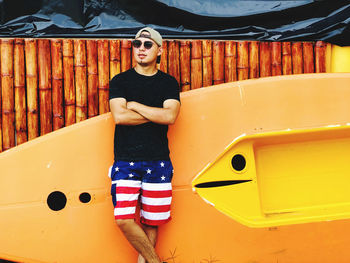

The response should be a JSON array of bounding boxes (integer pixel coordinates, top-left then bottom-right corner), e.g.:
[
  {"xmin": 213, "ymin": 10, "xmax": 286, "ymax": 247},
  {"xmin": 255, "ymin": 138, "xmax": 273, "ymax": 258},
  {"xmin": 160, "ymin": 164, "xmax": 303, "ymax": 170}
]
[{"xmin": 109, "ymin": 161, "xmax": 173, "ymax": 226}]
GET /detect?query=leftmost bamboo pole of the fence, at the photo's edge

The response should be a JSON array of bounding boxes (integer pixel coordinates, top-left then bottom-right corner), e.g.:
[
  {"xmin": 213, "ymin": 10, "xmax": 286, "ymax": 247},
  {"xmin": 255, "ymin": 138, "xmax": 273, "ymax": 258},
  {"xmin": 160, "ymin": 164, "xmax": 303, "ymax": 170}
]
[{"xmin": 0, "ymin": 39, "xmax": 15, "ymax": 151}]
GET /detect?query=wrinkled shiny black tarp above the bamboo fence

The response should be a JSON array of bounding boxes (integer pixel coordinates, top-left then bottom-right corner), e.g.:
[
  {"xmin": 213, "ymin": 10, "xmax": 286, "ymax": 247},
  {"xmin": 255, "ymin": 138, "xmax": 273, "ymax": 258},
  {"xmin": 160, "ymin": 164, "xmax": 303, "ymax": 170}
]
[{"xmin": 0, "ymin": 0, "xmax": 350, "ymax": 46}]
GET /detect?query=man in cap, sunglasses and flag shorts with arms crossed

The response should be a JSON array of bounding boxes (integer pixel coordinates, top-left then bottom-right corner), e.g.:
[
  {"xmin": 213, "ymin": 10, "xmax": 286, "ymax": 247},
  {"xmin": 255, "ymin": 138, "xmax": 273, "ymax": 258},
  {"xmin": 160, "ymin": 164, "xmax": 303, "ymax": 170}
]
[{"xmin": 110, "ymin": 27, "xmax": 180, "ymax": 263}]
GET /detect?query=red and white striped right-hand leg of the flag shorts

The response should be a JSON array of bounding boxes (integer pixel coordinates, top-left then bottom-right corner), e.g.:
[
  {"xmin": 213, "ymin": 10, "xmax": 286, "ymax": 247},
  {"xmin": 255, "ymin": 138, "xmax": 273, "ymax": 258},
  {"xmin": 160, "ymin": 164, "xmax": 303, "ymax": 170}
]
[{"xmin": 141, "ymin": 183, "xmax": 172, "ymax": 225}]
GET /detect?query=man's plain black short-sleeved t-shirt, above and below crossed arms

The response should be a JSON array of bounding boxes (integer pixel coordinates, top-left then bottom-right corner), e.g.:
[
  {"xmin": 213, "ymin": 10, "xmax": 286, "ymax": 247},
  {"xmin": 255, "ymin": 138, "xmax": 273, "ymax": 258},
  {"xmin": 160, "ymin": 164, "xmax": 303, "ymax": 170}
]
[{"xmin": 109, "ymin": 68, "xmax": 180, "ymax": 161}]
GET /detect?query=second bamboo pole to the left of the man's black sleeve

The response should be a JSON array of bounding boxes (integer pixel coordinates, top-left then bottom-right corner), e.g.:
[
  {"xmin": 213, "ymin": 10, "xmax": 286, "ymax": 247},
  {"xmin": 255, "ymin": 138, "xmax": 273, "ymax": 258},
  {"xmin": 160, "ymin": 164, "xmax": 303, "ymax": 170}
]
[{"xmin": 86, "ymin": 40, "xmax": 98, "ymax": 118}]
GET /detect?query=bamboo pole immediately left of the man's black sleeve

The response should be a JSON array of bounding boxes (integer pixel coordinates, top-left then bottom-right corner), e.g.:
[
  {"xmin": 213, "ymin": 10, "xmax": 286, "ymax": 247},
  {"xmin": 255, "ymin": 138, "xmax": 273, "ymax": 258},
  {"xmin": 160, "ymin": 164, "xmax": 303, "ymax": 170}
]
[{"xmin": 97, "ymin": 40, "xmax": 109, "ymax": 114}]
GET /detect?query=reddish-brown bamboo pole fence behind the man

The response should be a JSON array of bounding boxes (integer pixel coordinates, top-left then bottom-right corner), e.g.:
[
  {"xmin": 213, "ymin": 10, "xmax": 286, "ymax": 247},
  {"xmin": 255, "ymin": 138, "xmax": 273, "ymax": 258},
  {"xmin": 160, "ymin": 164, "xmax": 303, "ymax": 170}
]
[{"xmin": 0, "ymin": 39, "xmax": 328, "ymax": 152}]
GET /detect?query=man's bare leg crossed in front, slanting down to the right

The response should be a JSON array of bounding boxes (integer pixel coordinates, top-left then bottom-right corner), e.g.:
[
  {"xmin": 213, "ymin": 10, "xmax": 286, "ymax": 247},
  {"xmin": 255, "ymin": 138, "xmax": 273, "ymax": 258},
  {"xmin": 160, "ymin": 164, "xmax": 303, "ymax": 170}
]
[{"xmin": 117, "ymin": 219, "xmax": 161, "ymax": 263}]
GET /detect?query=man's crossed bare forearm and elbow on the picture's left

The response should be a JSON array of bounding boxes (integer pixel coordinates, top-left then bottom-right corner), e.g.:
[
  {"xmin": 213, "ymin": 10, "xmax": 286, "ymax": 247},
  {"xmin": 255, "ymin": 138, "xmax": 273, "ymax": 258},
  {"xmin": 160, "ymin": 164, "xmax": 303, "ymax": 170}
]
[{"xmin": 109, "ymin": 98, "xmax": 150, "ymax": 125}]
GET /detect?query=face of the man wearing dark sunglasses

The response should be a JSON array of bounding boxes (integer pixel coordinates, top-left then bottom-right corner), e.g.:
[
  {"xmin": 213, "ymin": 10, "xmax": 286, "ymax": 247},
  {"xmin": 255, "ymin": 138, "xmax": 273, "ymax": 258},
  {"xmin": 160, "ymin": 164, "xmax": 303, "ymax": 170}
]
[{"xmin": 133, "ymin": 33, "xmax": 162, "ymax": 65}]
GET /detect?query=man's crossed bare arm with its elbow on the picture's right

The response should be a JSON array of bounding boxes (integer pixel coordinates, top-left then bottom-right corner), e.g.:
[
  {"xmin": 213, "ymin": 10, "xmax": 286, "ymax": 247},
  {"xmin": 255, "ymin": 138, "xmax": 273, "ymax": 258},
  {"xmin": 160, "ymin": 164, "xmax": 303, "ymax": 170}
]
[{"xmin": 127, "ymin": 99, "xmax": 180, "ymax": 125}]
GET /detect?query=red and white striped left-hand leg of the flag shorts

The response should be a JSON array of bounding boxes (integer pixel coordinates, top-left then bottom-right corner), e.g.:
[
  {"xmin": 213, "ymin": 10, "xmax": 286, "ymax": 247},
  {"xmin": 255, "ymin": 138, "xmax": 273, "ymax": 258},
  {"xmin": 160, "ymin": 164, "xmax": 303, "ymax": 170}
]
[{"xmin": 112, "ymin": 180, "xmax": 141, "ymax": 219}]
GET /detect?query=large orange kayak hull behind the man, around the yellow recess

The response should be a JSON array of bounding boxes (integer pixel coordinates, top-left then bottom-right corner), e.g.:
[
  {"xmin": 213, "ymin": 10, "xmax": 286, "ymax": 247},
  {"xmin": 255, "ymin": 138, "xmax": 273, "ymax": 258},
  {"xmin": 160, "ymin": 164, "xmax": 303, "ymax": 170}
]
[{"xmin": 0, "ymin": 73, "xmax": 350, "ymax": 263}]
